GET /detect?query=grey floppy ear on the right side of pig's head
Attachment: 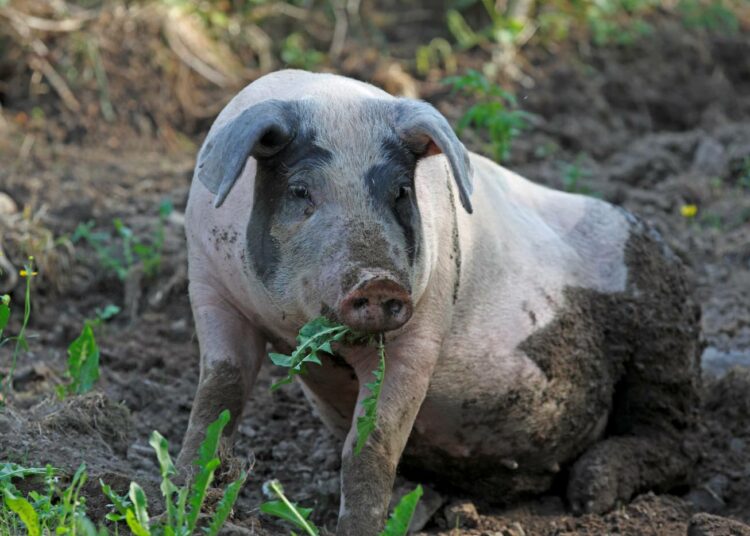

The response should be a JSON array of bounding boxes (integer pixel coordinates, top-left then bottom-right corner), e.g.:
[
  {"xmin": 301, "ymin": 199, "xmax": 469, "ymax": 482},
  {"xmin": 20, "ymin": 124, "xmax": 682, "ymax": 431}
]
[{"xmin": 394, "ymin": 99, "xmax": 473, "ymax": 214}]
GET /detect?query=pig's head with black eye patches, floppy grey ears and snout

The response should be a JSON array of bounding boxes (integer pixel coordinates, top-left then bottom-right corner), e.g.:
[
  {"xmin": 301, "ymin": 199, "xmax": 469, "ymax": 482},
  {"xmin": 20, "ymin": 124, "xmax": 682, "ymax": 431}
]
[{"xmin": 196, "ymin": 99, "xmax": 471, "ymax": 333}]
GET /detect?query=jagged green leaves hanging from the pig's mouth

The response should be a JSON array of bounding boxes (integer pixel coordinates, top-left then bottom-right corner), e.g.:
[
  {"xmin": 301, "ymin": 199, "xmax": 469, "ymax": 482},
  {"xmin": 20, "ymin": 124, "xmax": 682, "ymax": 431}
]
[{"xmin": 268, "ymin": 316, "xmax": 385, "ymax": 454}]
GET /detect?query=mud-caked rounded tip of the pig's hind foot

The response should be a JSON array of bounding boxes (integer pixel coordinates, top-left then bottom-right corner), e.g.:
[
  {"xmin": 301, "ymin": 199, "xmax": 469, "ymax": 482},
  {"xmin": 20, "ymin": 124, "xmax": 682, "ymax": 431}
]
[{"xmin": 568, "ymin": 452, "xmax": 623, "ymax": 514}]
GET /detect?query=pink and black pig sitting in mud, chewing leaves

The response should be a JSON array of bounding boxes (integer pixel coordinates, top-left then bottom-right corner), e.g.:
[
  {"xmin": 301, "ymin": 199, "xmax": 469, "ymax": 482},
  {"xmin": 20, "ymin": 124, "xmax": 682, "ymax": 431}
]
[{"xmin": 179, "ymin": 70, "xmax": 700, "ymax": 536}]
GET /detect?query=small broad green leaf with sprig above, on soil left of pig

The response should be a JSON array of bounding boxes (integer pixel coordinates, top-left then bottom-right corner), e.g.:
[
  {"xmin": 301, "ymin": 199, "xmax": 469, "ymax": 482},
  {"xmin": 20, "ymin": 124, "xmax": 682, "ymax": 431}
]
[{"xmin": 57, "ymin": 305, "xmax": 120, "ymax": 398}]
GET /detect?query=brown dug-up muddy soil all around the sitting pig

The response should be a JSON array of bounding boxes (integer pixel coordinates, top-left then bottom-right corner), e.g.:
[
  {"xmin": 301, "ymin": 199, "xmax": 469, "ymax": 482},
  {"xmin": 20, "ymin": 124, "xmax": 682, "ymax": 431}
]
[{"xmin": 0, "ymin": 16, "xmax": 750, "ymax": 536}]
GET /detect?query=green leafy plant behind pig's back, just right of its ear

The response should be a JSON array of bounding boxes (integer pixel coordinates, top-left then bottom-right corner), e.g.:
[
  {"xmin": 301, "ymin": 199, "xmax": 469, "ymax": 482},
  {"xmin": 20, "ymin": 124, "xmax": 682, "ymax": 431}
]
[{"xmin": 443, "ymin": 69, "xmax": 531, "ymax": 160}]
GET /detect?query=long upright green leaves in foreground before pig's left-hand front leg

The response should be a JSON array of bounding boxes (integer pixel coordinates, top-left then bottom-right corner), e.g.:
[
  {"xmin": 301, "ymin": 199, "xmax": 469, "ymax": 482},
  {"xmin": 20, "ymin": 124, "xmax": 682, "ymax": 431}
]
[{"xmin": 102, "ymin": 410, "xmax": 247, "ymax": 536}]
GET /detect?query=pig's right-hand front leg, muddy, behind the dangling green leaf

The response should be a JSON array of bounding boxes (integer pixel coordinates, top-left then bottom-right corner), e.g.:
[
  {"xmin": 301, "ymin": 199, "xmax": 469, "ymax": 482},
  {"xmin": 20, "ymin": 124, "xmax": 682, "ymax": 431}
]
[{"xmin": 336, "ymin": 341, "xmax": 439, "ymax": 536}]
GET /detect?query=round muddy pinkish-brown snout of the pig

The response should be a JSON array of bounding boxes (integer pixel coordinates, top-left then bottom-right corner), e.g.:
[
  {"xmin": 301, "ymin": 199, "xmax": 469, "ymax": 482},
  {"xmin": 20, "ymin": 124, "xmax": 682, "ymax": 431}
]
[{"xmin": 339, "ymin": 278, "xmax": 413, "ymax": 333}]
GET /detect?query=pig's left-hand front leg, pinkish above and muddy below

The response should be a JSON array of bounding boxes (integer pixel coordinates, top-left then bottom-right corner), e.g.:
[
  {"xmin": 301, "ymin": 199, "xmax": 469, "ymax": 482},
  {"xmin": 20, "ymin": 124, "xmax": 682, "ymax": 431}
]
[{"xmin": 177, "ymin": 282, "xmax": 265, "ymax": 474}]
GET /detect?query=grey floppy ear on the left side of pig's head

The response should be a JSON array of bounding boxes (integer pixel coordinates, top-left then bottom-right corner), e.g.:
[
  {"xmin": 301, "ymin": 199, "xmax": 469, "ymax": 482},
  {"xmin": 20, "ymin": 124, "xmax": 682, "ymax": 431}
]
[{"xmin": 194, "ymin": 100, "xmax": 299, "ymax": 207}]
